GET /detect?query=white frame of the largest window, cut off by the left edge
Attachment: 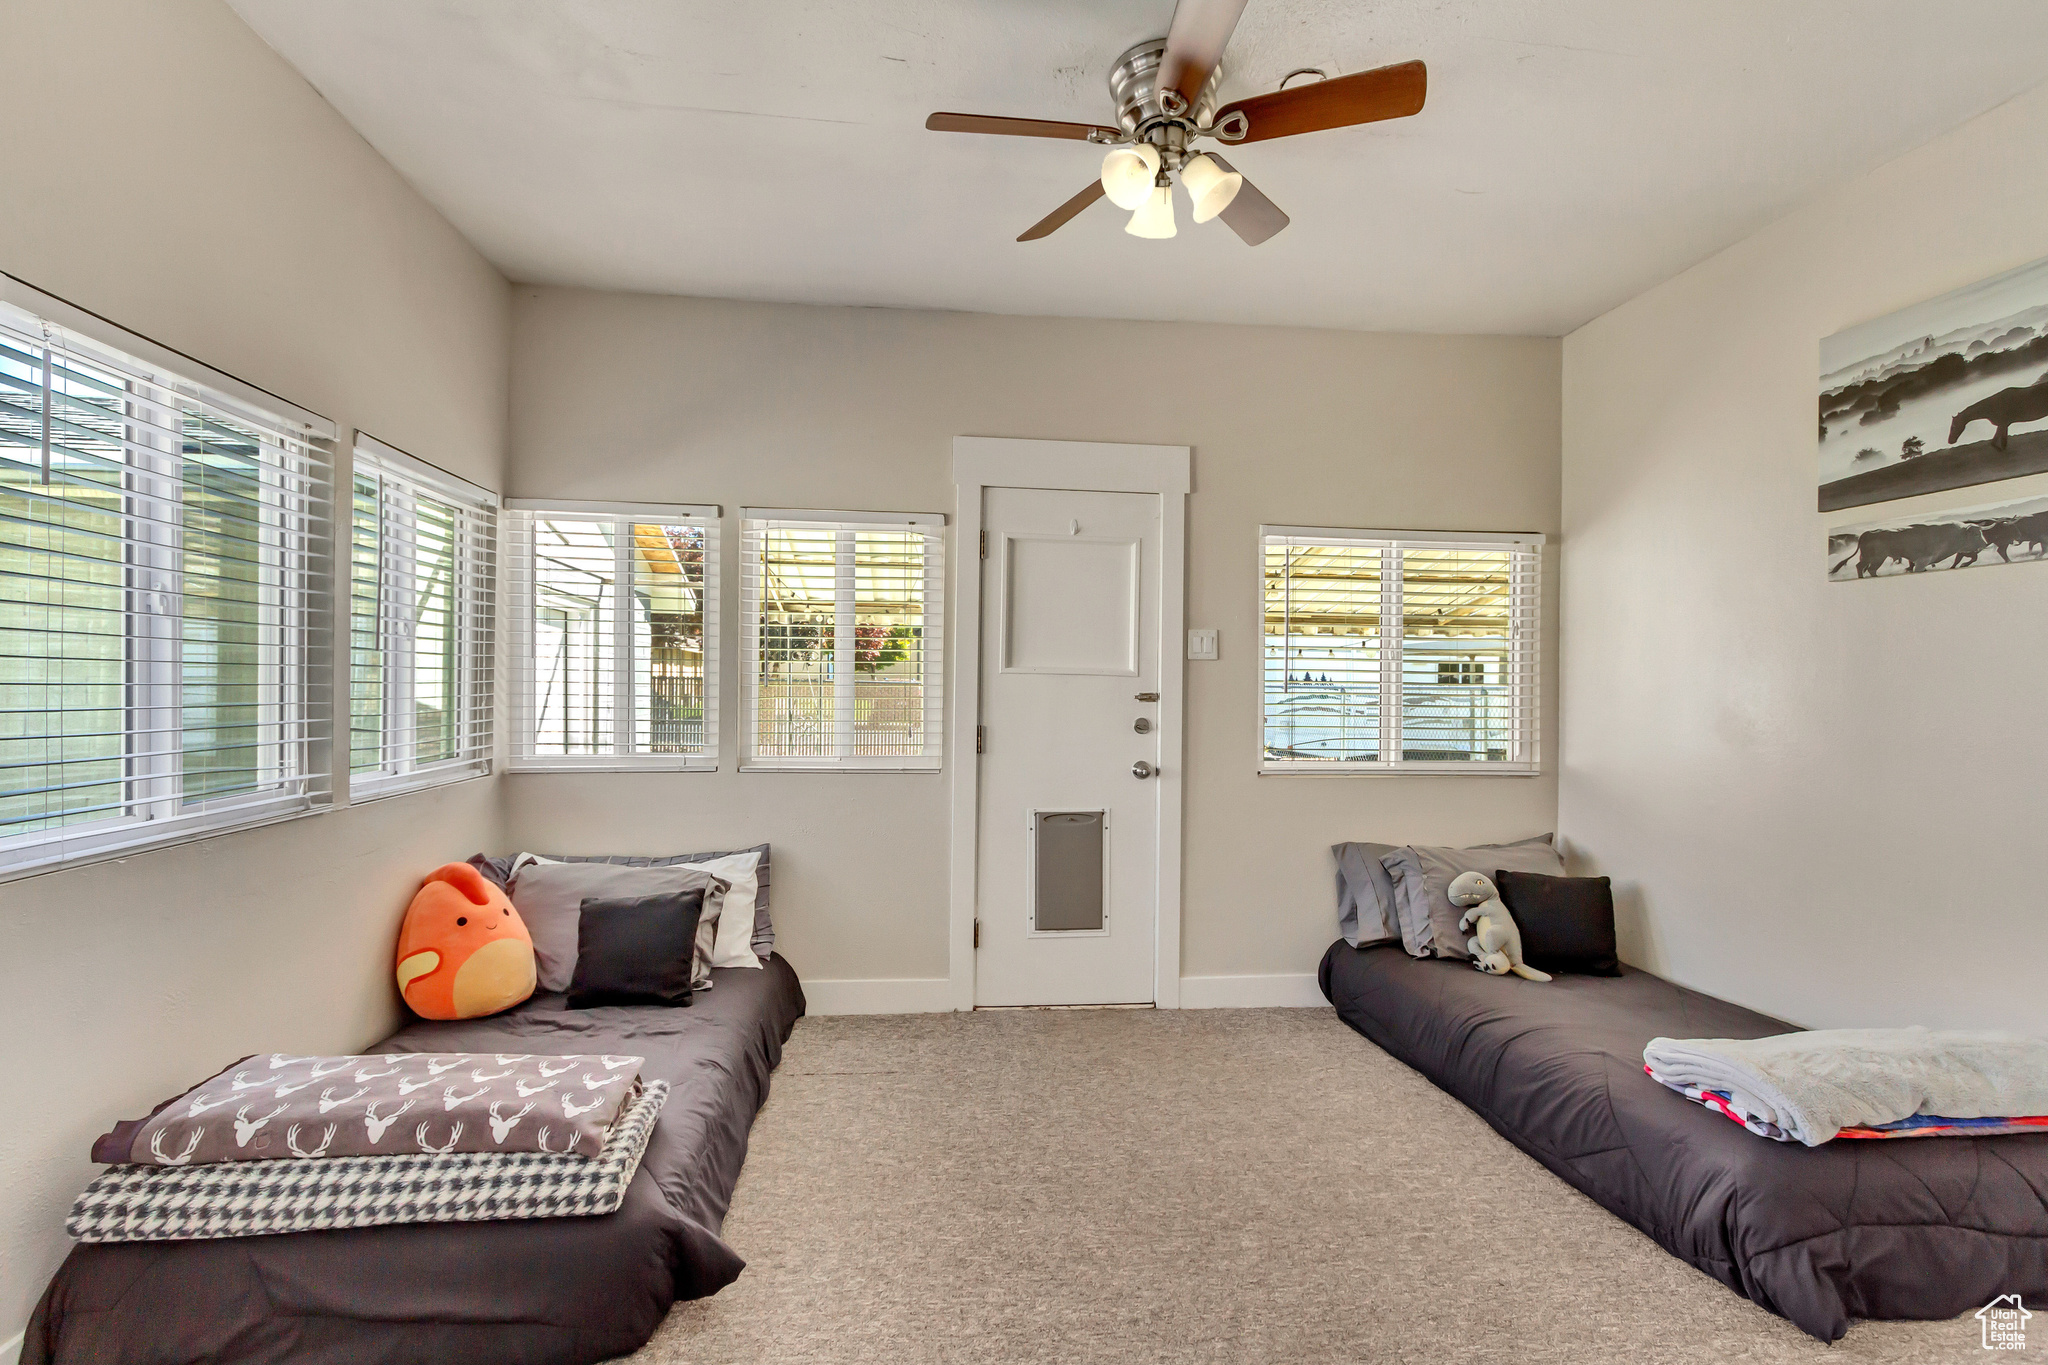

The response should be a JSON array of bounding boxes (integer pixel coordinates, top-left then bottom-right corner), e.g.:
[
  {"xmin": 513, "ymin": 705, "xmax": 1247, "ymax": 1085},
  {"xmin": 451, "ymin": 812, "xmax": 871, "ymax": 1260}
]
[{"xmin": 0, "ymin": 274, "xmax": 338, "ymax": 882}]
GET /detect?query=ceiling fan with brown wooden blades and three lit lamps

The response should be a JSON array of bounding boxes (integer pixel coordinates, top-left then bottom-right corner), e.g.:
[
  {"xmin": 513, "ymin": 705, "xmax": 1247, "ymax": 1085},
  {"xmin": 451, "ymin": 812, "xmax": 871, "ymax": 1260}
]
[{"xmin": 924, "ymin": 0, "xmax": 1427, "ymax": 246}]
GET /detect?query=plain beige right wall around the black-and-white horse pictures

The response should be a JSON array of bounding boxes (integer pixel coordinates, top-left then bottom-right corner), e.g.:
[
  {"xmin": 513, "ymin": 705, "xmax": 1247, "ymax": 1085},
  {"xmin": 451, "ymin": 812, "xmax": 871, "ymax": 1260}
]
[{"xmin": 1559, "ymin": 90, "xmax": 2048, "ymax": 1031}]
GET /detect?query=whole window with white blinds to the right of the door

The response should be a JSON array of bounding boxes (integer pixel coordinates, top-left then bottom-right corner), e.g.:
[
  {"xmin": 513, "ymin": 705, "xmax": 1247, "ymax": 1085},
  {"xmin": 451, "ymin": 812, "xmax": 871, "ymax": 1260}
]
[{"xmin": 1260, "ymin": 526, "xmax": 1542, "ymax": 774}]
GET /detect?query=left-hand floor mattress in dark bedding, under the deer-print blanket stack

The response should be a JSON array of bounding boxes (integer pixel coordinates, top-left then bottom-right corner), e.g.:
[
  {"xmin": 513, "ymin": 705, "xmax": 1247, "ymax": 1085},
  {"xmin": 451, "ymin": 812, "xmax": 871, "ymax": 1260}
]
[{"xmin": 20, "ymin": 956, "xmax": 803, "ymax": 1365}]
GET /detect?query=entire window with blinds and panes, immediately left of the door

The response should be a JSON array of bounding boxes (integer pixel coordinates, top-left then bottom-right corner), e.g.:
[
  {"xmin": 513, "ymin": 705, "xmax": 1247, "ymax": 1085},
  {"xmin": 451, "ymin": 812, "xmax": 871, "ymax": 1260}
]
[{"xmin": 739, "ymin": 508, "xmax": 946, "ymax": 772}]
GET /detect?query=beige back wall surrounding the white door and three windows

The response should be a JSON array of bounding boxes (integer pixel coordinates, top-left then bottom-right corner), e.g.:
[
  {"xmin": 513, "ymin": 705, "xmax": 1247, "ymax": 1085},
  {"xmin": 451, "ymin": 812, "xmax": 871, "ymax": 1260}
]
[{"xmin": 504, "ymin": 287, "xmax": 1559, "ymax": 994}]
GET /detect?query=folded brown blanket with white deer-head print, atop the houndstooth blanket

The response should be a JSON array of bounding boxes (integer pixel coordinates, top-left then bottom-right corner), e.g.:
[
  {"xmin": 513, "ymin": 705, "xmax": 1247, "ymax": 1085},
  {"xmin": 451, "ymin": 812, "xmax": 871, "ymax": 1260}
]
[{"xmin": 92, "ymin": 1052, "xmax": 643, "ymax": 1166}]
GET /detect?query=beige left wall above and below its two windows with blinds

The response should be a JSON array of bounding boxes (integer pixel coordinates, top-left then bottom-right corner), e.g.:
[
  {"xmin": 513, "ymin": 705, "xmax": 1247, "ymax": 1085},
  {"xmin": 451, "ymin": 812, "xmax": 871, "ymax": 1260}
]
[{"xmin": 0, "ymin": 0, "xmax": 508, "ymax": 1338}]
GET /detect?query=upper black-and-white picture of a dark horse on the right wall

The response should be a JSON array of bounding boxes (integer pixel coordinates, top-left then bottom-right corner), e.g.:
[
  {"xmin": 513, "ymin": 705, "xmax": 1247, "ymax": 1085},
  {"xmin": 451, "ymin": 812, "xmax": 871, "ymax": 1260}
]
[{"xmin": 1821, "ymin": 260, "xmax": 2048, "ymax": 512}]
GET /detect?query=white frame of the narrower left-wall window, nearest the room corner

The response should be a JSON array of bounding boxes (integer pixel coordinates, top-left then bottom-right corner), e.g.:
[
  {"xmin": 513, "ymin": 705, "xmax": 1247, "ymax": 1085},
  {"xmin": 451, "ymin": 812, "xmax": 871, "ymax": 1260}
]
[{"xmin": 348, "ymin": 432, "xmax": 498, "ymax": 804}]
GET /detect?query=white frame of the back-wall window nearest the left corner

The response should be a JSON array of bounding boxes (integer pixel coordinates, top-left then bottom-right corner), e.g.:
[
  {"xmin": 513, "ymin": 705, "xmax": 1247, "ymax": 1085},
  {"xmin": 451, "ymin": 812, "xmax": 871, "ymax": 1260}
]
[{"xmin": 504, "ymin": 497, "xmax": 723, "ymax": 774}]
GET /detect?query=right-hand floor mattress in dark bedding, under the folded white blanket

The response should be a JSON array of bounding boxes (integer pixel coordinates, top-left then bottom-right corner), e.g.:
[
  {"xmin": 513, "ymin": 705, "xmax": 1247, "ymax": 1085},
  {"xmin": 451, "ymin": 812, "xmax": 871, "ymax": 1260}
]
[{"xmin": 1321, "ymin": 941, "xmax": 2048, "ymax": 1340}]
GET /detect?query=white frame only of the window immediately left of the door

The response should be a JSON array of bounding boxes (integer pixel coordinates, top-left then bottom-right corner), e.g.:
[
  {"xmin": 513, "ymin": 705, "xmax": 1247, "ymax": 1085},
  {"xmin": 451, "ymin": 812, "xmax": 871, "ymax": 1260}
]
[{"xmin": 739, "ymin": 508, "xmax": 946, "ymax": 774}]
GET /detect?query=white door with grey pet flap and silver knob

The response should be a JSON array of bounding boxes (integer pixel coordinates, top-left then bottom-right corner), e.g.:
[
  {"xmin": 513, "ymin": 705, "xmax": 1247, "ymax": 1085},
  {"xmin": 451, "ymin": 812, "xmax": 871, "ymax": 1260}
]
[{"xmin": 975, "ymin": 487, "xmax": 1161, "ymax": 1005}]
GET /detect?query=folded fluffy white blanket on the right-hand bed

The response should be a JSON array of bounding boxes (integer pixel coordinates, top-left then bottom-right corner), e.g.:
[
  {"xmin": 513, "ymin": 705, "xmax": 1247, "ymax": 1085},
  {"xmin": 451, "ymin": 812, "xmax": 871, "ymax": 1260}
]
[{"xmin": 1642, "ymin": 1027, "xmax": 2048, "ymax": 1146}]
